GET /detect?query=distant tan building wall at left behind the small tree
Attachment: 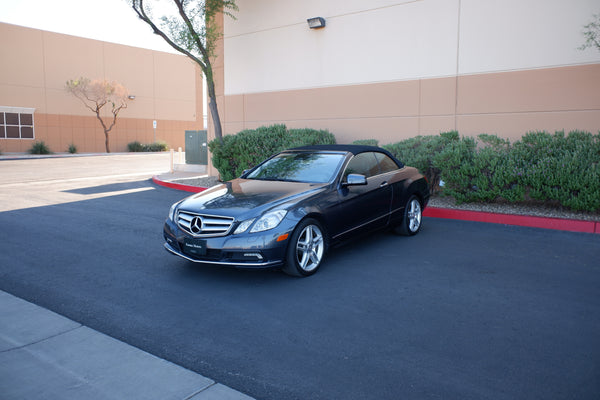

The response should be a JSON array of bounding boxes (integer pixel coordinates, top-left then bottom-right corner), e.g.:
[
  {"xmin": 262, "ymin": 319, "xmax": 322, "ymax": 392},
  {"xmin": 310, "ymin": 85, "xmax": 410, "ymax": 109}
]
[{"xmin": 0, "ymin": 23, "xmax": 203, "ymax": 152}]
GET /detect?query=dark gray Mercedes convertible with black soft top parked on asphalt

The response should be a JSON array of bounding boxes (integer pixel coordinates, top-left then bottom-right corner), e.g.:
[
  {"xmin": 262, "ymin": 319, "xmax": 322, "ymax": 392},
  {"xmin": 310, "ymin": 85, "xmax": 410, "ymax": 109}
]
[{"xmin": 164, "ymin": 145, "xmax": 429, "ymax": 276}]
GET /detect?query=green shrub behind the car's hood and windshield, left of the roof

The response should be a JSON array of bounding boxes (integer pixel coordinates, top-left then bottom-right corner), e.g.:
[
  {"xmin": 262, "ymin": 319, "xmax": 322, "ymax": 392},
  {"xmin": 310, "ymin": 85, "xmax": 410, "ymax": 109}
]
[{"xmin": 208, "ymin": 124, "xmax": 335, "ymax": 181}]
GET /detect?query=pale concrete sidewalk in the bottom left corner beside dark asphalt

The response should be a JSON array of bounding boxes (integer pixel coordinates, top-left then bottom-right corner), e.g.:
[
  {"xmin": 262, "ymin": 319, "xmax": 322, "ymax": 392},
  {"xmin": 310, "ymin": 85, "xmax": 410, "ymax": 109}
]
[{"xmin": 0, "ymin": 291, "xmax": 252, "ymax": 400}]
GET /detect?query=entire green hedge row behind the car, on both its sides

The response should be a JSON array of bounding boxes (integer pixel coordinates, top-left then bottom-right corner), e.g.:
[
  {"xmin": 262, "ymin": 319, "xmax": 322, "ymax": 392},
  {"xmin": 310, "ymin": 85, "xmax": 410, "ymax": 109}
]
[{"xmin": 209, "ymin": 125, "xmax": 600, "ymax": 212}]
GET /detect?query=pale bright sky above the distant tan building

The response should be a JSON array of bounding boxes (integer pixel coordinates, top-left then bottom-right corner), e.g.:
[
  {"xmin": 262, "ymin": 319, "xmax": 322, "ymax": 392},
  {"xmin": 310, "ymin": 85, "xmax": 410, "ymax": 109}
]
[{"xmin": 0, "ymin": 0, "xmax": 175, "ymax": 53}]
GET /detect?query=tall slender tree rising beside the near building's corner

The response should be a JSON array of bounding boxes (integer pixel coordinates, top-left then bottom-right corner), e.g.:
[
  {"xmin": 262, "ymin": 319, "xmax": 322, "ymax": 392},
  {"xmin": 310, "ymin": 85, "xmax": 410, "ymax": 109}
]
[{"xmin": 128, "ymin": 0, "xmax": 238, "ymax": 141}]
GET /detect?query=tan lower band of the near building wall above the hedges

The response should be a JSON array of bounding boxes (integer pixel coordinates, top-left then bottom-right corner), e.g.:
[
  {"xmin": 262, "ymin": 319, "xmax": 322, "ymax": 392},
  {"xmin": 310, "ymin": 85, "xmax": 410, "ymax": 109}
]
[{"xmin": 224, "ymin": 64, "xmax": 600, "ymax": 144}]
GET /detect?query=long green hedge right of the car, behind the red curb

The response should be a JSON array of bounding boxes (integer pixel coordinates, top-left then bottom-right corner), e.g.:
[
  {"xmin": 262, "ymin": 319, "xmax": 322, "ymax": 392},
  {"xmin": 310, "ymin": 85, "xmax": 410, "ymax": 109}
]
[{"xmin": 383, "ymin": 131, "xmax": 600, "ymax": 211}]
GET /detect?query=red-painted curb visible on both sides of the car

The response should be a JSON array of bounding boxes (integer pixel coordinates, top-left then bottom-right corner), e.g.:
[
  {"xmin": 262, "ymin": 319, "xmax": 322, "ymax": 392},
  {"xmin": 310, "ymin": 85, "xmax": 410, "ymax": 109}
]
[{"xmin": 152, "ymin": 176, "xmax": 600, "ymax": 234}]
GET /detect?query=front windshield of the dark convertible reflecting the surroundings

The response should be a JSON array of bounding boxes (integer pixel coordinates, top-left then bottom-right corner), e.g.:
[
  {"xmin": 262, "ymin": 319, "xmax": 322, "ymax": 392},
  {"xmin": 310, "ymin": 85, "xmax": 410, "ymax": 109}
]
[{"xmin": 246, "ymin": 153, "xmax": 344, "ymax": 183}]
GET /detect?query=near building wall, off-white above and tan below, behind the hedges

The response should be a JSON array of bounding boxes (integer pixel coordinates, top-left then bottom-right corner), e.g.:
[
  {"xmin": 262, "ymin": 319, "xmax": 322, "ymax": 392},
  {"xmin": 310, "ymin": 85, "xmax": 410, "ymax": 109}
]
[{"xmin": 220, "ymin": 0, "xmax": 600, "ymax": 144}]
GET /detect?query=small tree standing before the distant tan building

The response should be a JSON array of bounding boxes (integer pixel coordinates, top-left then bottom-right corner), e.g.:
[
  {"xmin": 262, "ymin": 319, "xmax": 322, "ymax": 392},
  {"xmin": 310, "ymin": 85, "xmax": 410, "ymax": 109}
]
[{"xmin": 66, "ymin": 77, "xmax": 129, "ymax": 153}]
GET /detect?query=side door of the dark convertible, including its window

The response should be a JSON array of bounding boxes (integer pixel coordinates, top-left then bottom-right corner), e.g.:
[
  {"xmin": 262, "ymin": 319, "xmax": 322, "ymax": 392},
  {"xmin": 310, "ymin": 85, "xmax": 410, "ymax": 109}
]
[{"xmin": 331, "ymin": 152, "xmax": 392, "ymax": 239}]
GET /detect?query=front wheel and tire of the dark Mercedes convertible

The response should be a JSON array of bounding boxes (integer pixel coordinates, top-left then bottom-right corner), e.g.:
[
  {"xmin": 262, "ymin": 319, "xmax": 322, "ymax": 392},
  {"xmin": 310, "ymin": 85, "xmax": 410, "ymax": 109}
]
[{"xmin": 283, "ymin": 218, "xmax": 327, "ymax": 277}]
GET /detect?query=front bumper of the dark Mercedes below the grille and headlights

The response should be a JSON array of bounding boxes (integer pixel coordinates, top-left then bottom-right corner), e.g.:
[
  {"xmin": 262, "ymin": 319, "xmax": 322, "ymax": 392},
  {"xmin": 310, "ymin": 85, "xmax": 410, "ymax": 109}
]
[{"xmin": 163, "ymin": 221, "xmax": 287, "ymax": 269}]
